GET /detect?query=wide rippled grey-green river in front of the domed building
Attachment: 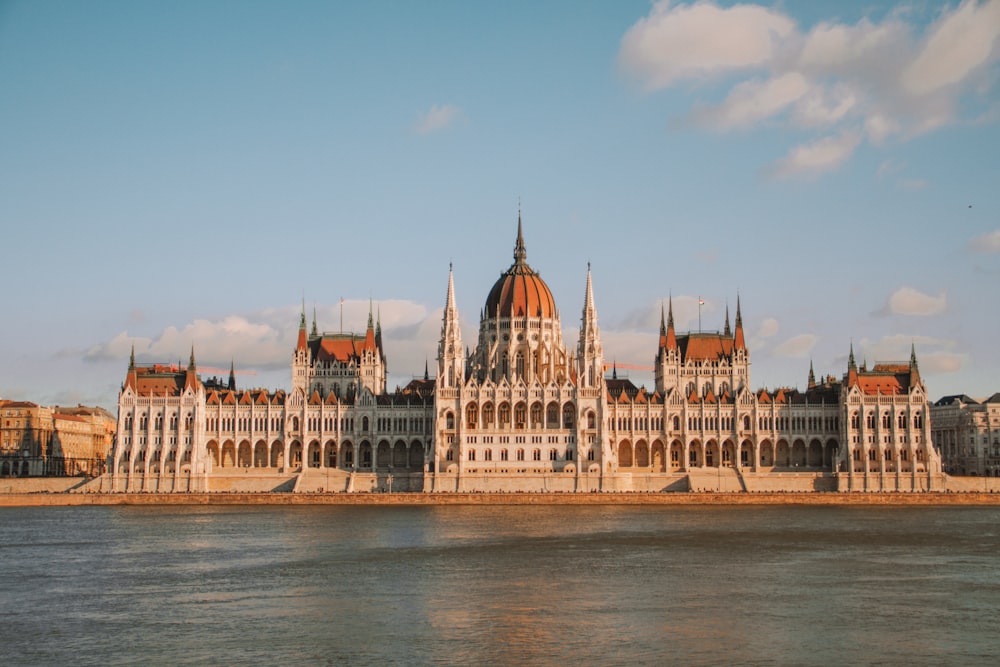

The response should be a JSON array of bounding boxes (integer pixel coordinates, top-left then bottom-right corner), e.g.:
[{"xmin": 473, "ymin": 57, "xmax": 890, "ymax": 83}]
[{"xmin": 0, "ymin": 506, "xmax": 1000, "ymax": 666}]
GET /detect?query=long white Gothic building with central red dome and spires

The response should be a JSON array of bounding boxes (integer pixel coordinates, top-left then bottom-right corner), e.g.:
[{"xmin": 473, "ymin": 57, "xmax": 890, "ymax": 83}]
[{"xmin": 109, "ymin": 216, "xmax": 941, "ymax": 492}]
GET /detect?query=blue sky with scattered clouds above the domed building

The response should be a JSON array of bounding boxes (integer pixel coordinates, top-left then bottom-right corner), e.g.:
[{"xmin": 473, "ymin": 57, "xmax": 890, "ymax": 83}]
[{"xmin": 0, "ymin": 0, "xmax": 1000, "ymax": 407}]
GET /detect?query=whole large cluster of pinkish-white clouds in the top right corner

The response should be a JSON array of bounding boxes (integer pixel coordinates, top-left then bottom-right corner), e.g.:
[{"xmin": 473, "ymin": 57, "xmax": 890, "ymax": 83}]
[{"xmin": 619, "ymin": 0, "xmax": 1000, "ymax": 177}]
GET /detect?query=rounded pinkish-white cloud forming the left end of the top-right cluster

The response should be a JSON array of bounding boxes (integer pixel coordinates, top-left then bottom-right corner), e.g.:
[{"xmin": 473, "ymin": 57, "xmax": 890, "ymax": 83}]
[{"xmin": 619, "ymin": 0, "xmax": 795, "ymax": 90}]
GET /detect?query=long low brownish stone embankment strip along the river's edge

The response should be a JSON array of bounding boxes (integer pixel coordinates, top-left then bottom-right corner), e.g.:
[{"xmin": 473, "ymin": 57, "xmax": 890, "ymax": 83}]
[{"xmin": 0, "ymin": 492, "xmax": 1000, "ymax": 507}]
